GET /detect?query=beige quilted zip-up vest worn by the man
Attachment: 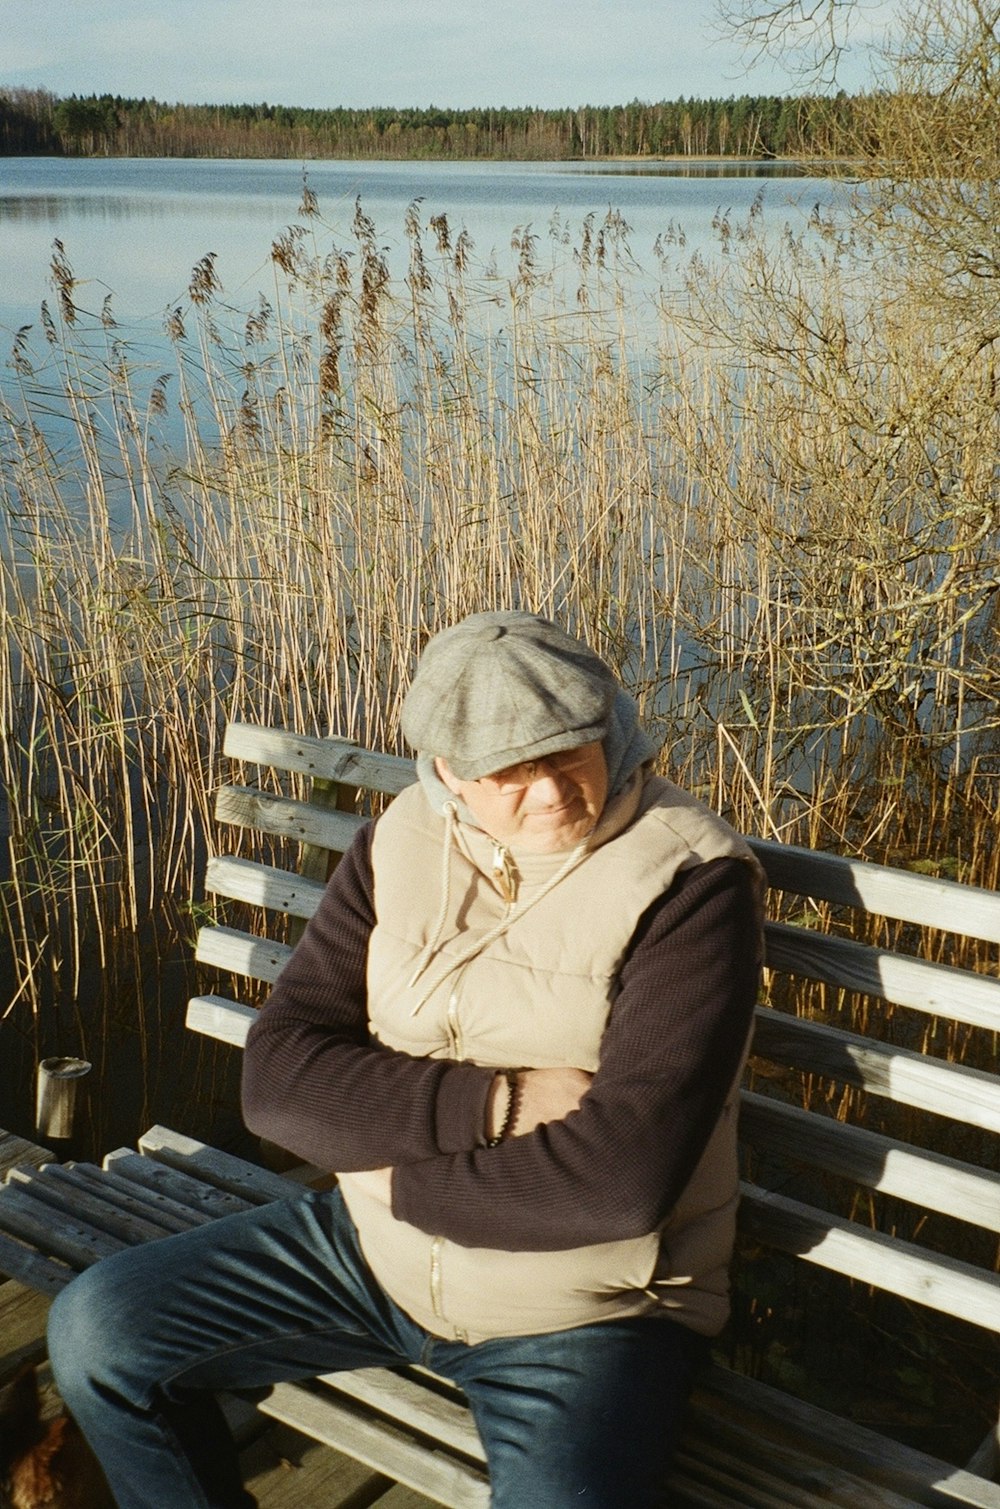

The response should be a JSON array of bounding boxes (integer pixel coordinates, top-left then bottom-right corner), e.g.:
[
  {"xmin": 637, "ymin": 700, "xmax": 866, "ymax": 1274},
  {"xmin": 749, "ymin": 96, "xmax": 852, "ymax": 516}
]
[{"xmin": 341, "ymin": 774, "xmax": 756, "ymax": 1342}]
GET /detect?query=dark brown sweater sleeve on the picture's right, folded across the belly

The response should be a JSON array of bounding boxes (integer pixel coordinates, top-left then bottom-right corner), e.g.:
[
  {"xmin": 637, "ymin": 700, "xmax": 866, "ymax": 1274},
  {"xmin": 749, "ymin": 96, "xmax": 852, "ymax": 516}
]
[{"xmin": 392, "ymin": 859, "xmax": 762, "ymax": 1251}]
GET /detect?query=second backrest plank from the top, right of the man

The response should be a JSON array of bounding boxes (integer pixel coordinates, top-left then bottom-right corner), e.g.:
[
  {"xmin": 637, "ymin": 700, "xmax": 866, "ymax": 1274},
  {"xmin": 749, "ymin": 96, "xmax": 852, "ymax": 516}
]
[{"xmin": 765, "ymin": 922, "xmax": 1000, "ymax": 1032}]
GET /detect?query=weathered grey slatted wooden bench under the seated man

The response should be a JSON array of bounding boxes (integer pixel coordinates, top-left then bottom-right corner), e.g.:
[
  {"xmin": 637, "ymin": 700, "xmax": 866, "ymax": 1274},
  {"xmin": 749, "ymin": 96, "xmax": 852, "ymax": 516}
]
[{"xmin": 0, "ymin": 724, "xmax": 1000, "ymax": 1509}]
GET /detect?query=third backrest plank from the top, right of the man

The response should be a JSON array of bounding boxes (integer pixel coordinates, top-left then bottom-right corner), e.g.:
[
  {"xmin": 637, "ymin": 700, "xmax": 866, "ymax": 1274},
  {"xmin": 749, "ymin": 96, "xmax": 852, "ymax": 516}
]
[{"xmin": 753, "ymin": 1007, "xmax": 1000, "ymax": 1132}]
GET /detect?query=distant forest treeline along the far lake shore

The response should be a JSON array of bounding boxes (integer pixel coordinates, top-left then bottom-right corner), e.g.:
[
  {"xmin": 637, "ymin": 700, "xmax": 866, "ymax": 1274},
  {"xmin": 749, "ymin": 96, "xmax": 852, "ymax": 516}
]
[{"xmin": 0, "ymin": 89, "xmax": 852, "ymax": 160}]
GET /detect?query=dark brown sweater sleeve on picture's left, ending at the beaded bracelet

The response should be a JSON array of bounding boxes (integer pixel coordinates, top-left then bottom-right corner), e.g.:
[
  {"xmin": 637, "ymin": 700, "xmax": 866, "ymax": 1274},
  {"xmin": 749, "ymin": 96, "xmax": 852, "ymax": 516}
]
[{"xmin": 243, "ymin": 824, "xmax": 493, "ymax": 1171}]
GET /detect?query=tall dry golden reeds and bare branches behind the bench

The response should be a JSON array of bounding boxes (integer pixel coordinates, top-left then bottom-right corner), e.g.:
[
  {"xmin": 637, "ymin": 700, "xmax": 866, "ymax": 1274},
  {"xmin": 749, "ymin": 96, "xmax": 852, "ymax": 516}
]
[{"xmin": 0, "ymin": 193, "xmax": 1000, "ymax": 1052}]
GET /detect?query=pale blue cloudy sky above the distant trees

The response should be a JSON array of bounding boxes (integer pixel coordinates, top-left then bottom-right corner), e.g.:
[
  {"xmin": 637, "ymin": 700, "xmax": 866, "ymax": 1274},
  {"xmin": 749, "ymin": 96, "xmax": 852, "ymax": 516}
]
[{"xmin": 0, "ymin": 0, "xmax": 892, "ymax": 109}]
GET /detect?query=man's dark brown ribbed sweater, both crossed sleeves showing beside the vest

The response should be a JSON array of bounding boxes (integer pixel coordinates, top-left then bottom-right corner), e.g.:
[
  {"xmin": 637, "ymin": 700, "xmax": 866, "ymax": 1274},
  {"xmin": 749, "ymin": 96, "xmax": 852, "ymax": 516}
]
[{"xmin": 243, "ymin": 828, "xmax": 762, "ymax": 1251}]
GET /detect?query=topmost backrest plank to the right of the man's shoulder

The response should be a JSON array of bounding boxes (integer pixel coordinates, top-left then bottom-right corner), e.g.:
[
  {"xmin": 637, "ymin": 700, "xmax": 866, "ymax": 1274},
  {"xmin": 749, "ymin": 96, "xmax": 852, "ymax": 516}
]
[{"xmin": 747, "ymin": 837, "xmax": 1000, "ymax": 943}]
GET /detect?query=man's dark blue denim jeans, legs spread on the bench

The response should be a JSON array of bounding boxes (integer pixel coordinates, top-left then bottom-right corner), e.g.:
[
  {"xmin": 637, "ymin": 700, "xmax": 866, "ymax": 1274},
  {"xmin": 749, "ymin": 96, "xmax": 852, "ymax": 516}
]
[{"xmin": 48, "ymin": 1191, "xmax": 706, "ymax": 1509}]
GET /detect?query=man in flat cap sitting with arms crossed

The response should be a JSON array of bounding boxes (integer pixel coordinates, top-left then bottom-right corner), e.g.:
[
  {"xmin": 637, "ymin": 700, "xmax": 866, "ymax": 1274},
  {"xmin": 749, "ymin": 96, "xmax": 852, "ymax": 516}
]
[{"xmin": 50, "ymin": 613, "xmax": 762, "ymax": 1509}]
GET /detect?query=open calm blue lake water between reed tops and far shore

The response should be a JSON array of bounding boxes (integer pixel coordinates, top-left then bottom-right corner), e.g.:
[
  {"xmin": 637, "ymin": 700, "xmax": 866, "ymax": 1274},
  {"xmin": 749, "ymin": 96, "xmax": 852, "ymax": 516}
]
[{"xmin": 0, "ymin": 157, "xmax": 834, "ymax": 345}]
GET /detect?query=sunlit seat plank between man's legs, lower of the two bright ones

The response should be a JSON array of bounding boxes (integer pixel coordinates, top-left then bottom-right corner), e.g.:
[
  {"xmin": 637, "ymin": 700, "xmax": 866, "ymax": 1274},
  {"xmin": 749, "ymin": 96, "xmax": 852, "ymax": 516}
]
[{"xmin": 258, "ymin": 1384, "xmax": 489, "ymax": 1509}]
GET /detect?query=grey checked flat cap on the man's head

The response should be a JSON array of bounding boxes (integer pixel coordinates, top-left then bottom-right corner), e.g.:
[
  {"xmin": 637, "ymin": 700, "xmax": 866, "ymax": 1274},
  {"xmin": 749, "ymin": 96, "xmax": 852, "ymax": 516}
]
[{"xmin": 401, "ymin": 613, "xmax": 618, "ymax": 780}]
